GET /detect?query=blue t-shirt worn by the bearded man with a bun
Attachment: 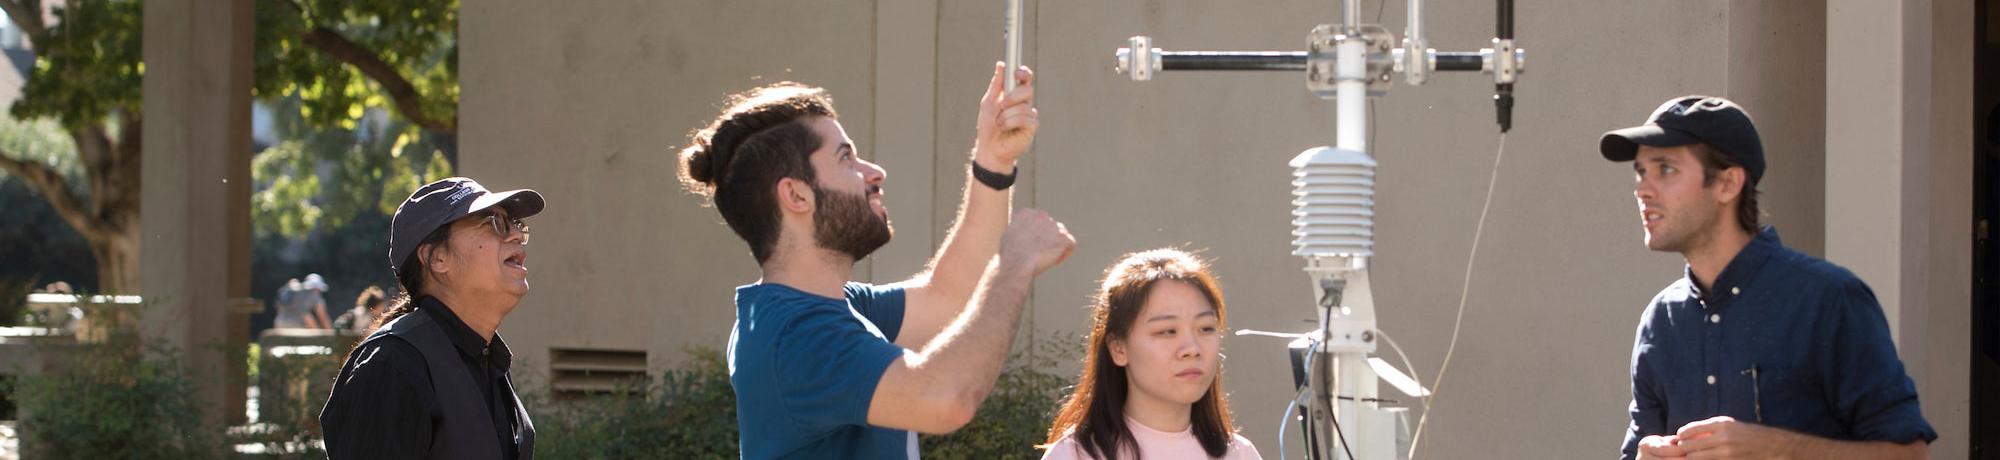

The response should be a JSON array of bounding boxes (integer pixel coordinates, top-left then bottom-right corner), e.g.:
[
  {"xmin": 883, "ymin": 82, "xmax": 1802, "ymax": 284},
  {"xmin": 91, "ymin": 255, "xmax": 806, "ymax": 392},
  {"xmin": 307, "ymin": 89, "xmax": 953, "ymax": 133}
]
[{"xmin": 728, "ymin": 282, "xmax": 916, "ymax": 458}]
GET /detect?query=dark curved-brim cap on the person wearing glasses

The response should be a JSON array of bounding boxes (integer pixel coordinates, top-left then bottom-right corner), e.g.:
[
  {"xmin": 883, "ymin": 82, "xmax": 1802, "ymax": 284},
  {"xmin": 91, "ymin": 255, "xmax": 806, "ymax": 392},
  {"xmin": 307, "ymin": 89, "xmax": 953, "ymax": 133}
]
[{"xmin": 388, "ymin": 178, "xmax": 544, "ymax": 276}]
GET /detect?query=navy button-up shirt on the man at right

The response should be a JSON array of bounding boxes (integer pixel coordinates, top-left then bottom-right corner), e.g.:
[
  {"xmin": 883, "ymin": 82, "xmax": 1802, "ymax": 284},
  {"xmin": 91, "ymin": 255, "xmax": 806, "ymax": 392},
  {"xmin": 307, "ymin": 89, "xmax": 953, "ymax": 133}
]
[{"xmin": 1622, "ymin": 226, "xmax": 1938, "ymax": 458}]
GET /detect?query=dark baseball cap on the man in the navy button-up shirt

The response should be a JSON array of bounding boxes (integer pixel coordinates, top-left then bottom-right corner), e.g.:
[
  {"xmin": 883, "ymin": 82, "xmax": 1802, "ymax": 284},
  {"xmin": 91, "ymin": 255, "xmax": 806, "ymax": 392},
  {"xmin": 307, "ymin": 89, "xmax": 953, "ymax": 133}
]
[{"xmin": 1598, "ymin": 96, "xmax": 1764, "ymax": 184}]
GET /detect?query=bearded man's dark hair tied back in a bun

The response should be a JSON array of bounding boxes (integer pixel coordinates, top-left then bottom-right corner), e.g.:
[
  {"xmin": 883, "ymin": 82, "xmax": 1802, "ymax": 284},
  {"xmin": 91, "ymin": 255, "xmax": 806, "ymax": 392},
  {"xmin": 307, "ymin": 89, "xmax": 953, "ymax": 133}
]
[{"xmin": 680, "ymin": 82, "xmax": 838, "ymax": 264}]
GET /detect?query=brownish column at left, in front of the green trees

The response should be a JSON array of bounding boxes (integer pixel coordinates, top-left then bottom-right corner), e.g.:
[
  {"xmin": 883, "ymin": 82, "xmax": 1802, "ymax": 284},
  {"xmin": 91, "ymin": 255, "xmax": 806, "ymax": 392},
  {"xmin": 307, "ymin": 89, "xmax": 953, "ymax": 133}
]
[{"xmin": 140, "ymin": 0, "xmax": 256, "ymax": 428}]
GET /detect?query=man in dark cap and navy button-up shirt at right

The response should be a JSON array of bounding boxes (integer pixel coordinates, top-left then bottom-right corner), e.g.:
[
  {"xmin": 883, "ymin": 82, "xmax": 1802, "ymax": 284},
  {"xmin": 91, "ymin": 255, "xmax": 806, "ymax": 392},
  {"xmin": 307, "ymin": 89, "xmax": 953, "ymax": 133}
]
[{"xmin": 1600, "ymin": 96, "xmax": 1938, "ymax": 458}]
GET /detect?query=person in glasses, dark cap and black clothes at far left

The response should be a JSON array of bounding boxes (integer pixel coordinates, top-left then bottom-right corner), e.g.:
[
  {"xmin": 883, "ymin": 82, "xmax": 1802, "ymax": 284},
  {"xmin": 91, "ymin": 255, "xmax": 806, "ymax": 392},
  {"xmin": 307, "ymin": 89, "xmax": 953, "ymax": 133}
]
[{"xmin": 320, "ymin": 178, "xmax": 542, "ymax": 458}]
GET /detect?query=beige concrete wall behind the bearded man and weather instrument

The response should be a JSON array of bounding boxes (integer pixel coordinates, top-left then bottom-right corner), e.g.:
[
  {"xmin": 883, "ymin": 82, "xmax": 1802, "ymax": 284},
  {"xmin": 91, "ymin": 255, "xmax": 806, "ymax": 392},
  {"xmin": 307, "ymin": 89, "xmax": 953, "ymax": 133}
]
[{"xmin": 460, "ymin": 0, "xmax": 1970, "ymax": 458}]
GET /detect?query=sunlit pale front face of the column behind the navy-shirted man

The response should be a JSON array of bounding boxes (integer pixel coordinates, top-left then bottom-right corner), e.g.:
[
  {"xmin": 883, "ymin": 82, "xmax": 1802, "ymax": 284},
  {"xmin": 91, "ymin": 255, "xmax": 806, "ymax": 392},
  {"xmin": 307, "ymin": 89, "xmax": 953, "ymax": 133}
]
[{"xmin": 1826, "ymin": 0, "xmax": 1930, "ymax": 352}]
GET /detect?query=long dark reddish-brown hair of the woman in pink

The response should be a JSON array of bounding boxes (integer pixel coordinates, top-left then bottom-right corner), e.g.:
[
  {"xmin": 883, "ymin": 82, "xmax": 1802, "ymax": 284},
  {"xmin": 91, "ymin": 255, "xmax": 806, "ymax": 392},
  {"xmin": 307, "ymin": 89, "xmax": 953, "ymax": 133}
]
[{"xmin": 1044, "ymin": 248, "xmax": 1236, "ymax": 458}]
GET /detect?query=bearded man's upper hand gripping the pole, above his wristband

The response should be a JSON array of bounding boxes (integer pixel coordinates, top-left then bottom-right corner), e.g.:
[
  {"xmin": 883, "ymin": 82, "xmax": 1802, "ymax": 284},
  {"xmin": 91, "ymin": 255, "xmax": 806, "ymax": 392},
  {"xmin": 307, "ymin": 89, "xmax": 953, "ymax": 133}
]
[{"xmin": 972, "ymin": 62, "xmax": 1042, "ymax": 174}]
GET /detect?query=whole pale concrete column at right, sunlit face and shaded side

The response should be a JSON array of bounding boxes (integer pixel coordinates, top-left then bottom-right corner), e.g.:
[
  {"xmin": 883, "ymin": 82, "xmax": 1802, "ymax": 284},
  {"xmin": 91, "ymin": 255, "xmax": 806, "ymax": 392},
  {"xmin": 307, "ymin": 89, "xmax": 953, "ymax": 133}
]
[{"xmin": 1826, "ymin": 0, "xmax": 1974, "ymax": 458}]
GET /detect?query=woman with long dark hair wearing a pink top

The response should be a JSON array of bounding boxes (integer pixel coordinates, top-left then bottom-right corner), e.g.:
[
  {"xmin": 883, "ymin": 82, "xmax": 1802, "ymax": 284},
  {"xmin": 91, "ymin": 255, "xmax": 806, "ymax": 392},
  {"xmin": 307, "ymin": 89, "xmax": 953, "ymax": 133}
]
[{"xmin": 1042, "ymin": 248, "xmax": 1262, "ymax": 460}]
